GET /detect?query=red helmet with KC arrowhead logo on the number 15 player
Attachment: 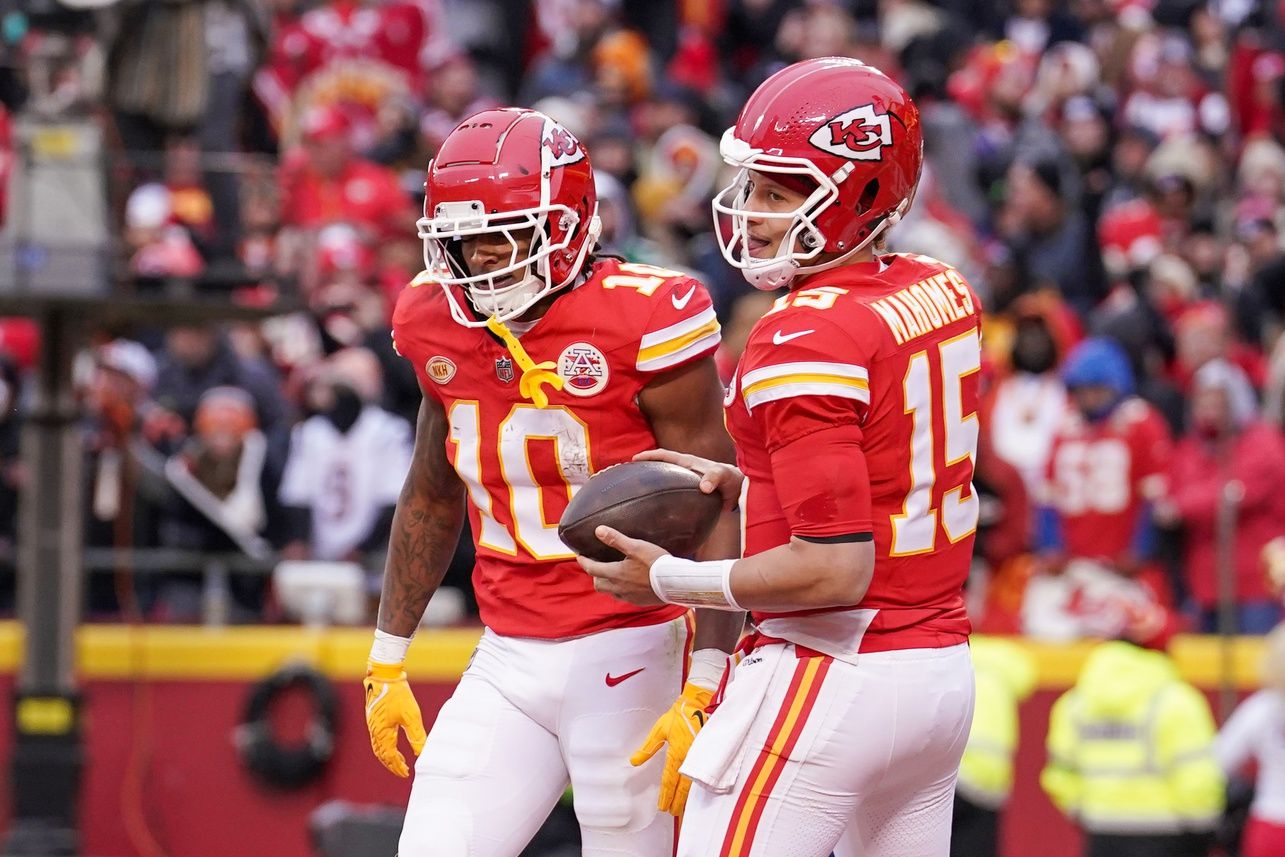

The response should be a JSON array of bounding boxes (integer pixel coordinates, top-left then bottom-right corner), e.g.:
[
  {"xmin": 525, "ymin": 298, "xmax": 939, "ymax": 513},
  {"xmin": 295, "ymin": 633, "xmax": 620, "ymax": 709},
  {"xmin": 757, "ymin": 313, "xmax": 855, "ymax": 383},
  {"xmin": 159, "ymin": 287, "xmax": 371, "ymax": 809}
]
[{"xmin": 713, "ymin": 57, "xmax": 924, "ymax": 289}]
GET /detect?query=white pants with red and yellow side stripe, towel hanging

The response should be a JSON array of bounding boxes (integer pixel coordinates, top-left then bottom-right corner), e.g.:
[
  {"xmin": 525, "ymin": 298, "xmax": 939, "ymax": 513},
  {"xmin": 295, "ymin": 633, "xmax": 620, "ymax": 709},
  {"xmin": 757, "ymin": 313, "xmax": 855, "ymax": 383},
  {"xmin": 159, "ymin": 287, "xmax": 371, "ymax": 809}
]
[{"xmin": 677, "ymin": 644, "xmax": 973, "ymax": 857}]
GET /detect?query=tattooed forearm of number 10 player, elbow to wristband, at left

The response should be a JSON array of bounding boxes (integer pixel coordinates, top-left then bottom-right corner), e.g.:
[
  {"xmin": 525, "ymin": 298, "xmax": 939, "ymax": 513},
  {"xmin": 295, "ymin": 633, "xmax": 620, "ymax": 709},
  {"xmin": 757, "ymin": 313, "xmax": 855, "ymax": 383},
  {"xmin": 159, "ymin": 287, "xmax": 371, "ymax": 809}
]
[{"xmin": 379, "ymin": 491, "xmax": 464, "ymax": 637}]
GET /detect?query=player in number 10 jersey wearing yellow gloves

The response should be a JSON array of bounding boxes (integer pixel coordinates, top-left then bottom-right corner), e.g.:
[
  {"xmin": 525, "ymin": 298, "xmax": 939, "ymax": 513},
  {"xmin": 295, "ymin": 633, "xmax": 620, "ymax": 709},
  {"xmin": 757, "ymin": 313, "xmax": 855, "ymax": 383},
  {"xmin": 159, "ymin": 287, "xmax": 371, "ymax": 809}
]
[{"xmin": 365, "ymin": 109, "xmax": 743, "ymax": 857}]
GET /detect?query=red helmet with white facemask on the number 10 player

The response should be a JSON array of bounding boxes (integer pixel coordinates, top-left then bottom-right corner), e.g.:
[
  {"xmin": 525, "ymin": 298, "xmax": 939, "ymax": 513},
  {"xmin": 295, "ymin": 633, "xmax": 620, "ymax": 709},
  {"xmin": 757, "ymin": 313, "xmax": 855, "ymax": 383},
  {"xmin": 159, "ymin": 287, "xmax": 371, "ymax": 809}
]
[{"xmin": 418, "ymin": 108, "xmax": 601, "ymax": 328}]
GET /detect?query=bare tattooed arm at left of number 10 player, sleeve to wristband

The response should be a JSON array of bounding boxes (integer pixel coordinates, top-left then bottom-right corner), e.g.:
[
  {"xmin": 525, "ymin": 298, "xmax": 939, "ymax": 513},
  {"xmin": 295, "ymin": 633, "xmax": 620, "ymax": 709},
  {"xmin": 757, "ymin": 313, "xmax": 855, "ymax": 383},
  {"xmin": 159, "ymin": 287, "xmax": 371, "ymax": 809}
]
[{"xmin": 379, "ymin": 394, "xmax": 465, "ymax": 637}]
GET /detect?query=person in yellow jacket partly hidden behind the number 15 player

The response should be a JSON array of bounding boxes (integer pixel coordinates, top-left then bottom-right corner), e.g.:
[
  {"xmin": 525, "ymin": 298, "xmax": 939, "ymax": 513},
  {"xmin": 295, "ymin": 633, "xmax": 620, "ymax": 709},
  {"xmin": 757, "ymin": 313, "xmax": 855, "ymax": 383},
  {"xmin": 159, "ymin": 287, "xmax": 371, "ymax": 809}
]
[{"xmin": 951, "ymin": 635, "xmax": 1036, "ymax": 857}]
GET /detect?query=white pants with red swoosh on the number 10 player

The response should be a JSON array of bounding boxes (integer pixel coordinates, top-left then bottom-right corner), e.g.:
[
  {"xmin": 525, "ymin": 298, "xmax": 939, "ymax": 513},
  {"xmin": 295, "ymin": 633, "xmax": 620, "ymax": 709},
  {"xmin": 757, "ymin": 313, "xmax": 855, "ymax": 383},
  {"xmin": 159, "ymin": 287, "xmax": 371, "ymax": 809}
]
[{"xmin": 398, "ymin": 618, "xmax": 689, "ymax": 857}]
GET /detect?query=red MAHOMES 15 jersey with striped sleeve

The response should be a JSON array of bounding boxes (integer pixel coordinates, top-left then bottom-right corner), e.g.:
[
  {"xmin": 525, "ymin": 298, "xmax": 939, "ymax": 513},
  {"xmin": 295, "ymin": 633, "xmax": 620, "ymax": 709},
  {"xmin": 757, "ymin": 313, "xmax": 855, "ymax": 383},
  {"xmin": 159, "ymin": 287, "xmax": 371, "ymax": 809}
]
[{"xmin": 727, "ymin": 254, "xmax": 982, "ymax": 651}]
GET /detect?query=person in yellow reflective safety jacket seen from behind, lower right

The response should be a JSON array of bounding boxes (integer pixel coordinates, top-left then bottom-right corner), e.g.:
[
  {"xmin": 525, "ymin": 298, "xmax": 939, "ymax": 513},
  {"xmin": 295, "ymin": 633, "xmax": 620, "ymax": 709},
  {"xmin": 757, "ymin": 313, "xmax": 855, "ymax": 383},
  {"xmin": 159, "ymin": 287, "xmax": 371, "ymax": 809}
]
[{"xmin": 1040, "ymin": 604, "xmax": 1225, "ymax": 857}]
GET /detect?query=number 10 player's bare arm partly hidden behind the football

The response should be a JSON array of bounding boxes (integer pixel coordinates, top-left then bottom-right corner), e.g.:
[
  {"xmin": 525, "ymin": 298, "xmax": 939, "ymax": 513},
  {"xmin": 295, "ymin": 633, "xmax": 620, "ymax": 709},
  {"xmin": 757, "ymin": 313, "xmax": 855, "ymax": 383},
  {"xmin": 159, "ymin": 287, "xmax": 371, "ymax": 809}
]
[{"xmin": 639, "ymin": 357, "xmax": 744, "ymax": 651}]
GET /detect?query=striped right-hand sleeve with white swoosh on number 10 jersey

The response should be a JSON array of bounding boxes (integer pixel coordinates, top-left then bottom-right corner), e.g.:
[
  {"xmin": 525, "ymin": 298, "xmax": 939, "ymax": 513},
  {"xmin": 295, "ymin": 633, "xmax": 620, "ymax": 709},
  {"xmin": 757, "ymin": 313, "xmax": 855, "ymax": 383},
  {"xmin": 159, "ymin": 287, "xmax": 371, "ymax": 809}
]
[{"xmin": 635, "ymin": 278, "xmax": 721, "ymax": 374}]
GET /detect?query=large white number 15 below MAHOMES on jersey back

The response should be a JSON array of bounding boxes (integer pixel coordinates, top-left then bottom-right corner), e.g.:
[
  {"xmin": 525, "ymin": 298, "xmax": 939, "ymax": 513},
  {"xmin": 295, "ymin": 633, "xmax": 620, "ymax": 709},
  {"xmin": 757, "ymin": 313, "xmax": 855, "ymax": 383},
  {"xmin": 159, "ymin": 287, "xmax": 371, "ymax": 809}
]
[{"xmin": 888, "ymin": 330, "xmax": 982, "ymax": 556}]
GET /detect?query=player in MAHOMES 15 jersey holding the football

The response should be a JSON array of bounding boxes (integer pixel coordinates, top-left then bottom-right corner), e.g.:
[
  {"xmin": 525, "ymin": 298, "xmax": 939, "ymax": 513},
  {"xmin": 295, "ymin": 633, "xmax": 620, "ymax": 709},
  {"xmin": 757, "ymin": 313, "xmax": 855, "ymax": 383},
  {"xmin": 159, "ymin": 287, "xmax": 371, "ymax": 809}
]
[{"xmin": 581, "ymin": 58, "xmax": 982, "ymax": 857}]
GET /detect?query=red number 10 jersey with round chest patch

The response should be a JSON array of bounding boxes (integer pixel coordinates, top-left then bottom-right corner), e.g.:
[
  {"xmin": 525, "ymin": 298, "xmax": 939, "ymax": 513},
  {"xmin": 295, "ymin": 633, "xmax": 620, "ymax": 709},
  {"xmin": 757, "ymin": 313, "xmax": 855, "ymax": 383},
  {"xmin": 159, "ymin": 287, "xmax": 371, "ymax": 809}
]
[{"xmin": 393, "ymin": 258, "xmax": 718, "ymax": 639}]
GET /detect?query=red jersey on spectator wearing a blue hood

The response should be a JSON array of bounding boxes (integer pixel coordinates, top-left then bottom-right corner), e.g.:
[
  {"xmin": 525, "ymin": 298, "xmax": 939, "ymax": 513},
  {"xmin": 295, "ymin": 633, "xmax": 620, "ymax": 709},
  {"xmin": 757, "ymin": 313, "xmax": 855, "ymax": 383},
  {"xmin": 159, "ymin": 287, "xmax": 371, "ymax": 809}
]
[{"xmin": 1042, "ymin": 398, "xmax": 1172, "ymax": 564}]
